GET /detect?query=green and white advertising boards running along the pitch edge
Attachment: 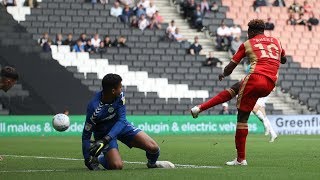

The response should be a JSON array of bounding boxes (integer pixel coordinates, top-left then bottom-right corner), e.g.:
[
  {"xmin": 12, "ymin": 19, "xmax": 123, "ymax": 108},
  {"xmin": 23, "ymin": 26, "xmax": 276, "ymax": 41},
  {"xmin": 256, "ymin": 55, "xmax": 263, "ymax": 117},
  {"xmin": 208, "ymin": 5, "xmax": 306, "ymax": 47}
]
[{"xmin": 0, "ymin": 115, "xmax": 320, "ymax": 136}]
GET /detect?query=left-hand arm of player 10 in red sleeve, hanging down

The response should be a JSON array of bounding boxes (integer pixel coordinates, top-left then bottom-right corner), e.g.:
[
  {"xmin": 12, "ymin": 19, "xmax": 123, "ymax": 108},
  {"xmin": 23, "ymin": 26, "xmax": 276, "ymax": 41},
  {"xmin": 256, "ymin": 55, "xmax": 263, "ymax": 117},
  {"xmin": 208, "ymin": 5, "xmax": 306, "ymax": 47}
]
[{"xmin": 219, "ymin": 44, "xmax": 246, "ymax": 81}]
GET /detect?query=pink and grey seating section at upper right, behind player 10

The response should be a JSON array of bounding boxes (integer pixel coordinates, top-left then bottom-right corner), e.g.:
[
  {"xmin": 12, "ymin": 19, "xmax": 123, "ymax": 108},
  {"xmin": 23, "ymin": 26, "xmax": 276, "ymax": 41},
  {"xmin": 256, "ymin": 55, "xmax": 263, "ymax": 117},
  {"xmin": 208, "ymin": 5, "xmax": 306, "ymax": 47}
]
[{"xmin": 218, "ymin": 0, "xmax": 320, "ymax": 113}]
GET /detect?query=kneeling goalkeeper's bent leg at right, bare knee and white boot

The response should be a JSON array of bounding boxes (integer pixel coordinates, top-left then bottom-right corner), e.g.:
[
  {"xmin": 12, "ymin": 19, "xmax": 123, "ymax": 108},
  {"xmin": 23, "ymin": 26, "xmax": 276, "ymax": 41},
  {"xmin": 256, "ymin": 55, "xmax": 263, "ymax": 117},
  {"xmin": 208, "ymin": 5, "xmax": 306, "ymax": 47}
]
[{"xmin": 131, "ymin": 131, "xmax": 174, "ymax": 168}]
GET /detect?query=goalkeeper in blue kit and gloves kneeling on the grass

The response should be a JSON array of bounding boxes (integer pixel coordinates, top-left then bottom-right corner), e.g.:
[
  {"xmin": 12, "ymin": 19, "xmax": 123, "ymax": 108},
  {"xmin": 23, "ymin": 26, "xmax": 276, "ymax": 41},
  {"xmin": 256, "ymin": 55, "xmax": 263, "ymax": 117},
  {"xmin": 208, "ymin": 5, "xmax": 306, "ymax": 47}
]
[{"xmin": 82, "ymin": 74, "xmax": 174, "ymax": 170}]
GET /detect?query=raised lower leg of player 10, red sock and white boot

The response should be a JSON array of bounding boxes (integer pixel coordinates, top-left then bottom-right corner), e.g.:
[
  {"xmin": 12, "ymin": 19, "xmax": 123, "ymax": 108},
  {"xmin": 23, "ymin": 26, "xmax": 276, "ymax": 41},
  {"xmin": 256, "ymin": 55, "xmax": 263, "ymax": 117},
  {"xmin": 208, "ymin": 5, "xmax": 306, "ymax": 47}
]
[{"xmin": 190, "ymin": 82, "xmax": 240, "ymax": 118}]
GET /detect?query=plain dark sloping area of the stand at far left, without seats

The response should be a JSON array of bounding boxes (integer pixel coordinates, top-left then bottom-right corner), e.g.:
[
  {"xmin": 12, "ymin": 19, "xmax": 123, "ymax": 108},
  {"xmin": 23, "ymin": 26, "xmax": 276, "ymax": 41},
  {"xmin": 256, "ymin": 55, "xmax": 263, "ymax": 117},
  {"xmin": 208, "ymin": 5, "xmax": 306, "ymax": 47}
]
[{"xmin": 0, "ymin": 6, "xmax": 92, "ymax": 114}]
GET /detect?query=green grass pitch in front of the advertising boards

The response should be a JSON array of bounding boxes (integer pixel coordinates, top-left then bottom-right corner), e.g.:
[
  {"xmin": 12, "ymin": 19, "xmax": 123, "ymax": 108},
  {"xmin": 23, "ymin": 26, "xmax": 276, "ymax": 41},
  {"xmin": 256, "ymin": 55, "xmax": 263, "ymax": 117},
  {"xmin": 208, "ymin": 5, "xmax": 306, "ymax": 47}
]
[{"xmin": 0, "ymin": 134, "xmax": 320, "ymax": 180}]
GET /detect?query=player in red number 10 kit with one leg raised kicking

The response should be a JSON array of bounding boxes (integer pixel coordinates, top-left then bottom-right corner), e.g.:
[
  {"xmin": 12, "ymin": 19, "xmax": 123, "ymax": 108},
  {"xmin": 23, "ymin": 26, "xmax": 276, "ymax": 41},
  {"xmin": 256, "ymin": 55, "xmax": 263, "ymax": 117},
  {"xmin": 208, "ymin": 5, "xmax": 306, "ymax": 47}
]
[{"xmin": 191, "ymin": 19, "xmax": 286, "ymax": 165}]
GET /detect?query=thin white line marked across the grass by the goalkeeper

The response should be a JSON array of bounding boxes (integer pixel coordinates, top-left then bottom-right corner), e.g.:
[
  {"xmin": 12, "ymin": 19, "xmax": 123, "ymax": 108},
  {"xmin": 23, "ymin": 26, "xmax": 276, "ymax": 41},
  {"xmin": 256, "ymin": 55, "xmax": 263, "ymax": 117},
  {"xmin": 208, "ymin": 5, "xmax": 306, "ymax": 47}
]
[{"xmin": 0, "ymin": 154, "xmax": 222, "ymax": 169}]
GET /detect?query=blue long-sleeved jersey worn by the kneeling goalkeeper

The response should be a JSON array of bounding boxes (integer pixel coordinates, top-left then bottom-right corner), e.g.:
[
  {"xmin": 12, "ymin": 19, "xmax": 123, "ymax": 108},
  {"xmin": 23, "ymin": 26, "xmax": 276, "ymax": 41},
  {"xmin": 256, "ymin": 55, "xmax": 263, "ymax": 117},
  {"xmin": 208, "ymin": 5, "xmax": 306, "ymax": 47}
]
[{"xmin": 82, "ymin": 92, "xmax": 130, "ymax": 159}]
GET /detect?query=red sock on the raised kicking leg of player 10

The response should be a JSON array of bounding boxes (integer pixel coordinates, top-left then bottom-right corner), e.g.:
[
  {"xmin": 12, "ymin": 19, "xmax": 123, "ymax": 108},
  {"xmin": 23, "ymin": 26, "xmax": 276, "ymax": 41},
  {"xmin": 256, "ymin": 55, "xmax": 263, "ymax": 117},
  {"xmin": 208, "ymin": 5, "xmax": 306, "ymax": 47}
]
[{"xmin": 200, "ymin": 89, "xmax": 235, "ymax": 111}]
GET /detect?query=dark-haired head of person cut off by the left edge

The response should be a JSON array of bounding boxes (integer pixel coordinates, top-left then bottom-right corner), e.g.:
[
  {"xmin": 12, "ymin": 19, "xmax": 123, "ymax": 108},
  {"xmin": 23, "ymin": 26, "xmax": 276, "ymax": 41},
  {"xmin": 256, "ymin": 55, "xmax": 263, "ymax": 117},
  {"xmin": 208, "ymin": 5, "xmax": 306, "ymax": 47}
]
[{"xmin": 0, "ymin": 66, "xmax": 19, "ymax": 161}]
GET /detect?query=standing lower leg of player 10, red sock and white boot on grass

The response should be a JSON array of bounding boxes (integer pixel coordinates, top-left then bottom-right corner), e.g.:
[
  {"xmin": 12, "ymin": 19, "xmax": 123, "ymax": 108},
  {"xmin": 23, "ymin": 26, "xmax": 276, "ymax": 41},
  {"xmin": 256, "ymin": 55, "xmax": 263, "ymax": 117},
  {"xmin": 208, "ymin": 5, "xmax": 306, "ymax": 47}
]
[{"xmin": 226, "ymin": 110, "xmax": 250, "ymax": 166}]
